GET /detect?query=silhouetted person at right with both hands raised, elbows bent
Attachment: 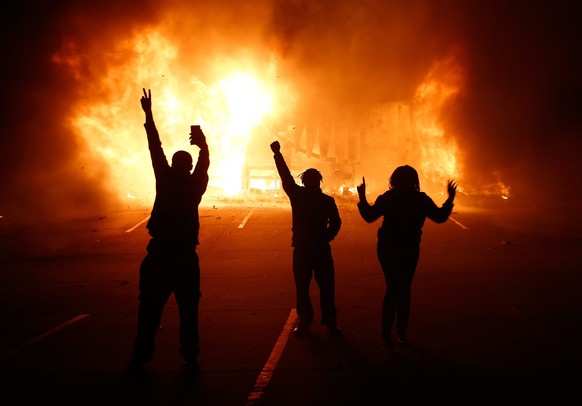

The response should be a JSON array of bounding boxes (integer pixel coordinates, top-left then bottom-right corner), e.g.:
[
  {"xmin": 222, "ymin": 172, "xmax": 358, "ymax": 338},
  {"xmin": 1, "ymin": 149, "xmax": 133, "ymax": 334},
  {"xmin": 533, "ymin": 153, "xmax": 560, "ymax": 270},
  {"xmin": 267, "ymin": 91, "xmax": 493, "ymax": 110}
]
[{"xmin": 357, "ymin": 165, "xmax": 457, "ymax": 347}]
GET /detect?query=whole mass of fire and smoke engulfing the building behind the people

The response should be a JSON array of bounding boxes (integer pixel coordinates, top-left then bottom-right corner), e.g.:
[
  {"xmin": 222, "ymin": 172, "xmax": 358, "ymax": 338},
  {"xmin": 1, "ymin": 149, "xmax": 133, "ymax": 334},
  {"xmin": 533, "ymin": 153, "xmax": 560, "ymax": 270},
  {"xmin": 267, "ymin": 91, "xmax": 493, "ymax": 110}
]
[{"xmin": 0, "ymin": 0, "xmax": 581, "ymax": 222}]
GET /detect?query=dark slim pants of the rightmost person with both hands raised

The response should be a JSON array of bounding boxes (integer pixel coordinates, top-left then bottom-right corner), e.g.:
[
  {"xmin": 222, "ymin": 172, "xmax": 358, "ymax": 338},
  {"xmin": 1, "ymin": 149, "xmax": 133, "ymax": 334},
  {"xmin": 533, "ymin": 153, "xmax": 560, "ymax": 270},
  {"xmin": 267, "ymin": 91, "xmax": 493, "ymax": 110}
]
[{"xmin": 377, "ymin": 242, "xmax": 420, "ymax": 333}]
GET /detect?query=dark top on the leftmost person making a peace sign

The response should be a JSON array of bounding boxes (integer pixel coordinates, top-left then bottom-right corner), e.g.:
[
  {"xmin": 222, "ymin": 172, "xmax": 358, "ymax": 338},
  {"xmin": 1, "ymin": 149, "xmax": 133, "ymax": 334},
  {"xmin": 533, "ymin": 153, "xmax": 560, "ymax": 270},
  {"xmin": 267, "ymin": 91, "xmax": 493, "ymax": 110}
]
[{"xmin": 144, "ymin": 122, "xmax": 210, "ymax": 246}]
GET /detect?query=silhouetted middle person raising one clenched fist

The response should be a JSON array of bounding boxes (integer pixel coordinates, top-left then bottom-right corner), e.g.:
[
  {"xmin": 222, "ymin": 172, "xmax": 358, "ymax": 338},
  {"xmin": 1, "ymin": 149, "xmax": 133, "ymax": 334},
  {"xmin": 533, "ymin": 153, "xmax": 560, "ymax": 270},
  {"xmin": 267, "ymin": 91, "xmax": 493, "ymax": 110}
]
[{"xmin": 271, "ymin": 141, "xmax": 341, "ymax": 336}]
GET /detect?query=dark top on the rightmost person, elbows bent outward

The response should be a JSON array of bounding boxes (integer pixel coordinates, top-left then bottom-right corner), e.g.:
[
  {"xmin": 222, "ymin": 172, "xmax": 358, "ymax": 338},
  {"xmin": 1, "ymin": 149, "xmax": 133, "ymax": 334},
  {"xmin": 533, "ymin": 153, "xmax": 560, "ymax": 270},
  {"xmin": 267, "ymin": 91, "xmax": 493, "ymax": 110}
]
[{"xmin": 358, "ymin": 189, "xmax": 453, "ymax": 247}]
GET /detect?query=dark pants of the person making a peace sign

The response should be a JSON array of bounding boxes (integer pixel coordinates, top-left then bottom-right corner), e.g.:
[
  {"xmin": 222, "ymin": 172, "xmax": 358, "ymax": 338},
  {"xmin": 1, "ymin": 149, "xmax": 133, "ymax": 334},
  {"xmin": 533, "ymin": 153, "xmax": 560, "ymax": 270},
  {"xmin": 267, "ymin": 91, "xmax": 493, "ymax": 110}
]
[{"xmin": 134, "ymin": 239, "xmax": 200, "ymax": 362}]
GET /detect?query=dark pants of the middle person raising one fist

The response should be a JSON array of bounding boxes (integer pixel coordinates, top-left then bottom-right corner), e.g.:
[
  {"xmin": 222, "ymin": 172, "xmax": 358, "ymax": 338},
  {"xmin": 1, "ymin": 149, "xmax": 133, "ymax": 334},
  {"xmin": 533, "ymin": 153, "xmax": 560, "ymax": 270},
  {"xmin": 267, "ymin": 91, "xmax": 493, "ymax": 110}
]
[{"xmin": 293, "ymin": 245, "xmax": 337, "ymax": 325}]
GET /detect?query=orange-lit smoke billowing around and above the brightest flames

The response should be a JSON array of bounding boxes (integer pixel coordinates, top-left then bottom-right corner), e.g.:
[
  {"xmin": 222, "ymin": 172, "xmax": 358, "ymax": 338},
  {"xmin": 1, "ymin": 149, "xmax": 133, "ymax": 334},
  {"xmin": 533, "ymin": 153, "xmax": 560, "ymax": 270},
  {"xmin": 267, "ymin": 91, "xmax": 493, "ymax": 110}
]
[{"xmin": 0, "ymin": 0, "xmax": 582, "ymax": 224}]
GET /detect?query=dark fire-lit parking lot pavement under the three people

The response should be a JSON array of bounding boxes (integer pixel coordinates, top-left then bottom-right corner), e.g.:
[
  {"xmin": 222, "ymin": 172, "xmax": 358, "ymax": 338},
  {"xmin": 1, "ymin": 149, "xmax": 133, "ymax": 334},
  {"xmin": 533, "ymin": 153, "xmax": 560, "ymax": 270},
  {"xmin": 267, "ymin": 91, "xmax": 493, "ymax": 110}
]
[{"xmin": 0, "ymin": 198, "xmax": 582, "ymax": 405}]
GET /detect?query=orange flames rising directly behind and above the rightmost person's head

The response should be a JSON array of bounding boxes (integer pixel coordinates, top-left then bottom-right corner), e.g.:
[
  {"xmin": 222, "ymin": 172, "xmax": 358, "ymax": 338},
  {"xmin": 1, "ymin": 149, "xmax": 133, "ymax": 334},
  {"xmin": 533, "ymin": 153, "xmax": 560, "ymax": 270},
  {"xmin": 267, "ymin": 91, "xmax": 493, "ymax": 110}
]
[{"xmin": 357, "ymin": 57, "xmax": 463, "ymax": 199}]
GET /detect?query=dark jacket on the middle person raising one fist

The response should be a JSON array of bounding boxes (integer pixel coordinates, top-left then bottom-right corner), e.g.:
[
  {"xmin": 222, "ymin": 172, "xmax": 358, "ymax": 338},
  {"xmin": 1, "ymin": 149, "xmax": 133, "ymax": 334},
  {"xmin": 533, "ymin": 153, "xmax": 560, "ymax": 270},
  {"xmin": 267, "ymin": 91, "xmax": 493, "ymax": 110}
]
[{"xmin": 274, "ymin": 153, "xmax": 342, "ymax": 248}]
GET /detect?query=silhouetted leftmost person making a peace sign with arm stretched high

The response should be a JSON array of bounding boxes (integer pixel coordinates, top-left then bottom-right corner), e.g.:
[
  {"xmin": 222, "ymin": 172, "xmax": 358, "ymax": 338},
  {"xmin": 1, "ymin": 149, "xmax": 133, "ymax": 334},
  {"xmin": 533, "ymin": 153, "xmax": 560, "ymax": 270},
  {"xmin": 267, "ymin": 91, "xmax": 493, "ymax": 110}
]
[{"xmin": 128, "ymin": 89, "xmax": 210, "ymax": 373}]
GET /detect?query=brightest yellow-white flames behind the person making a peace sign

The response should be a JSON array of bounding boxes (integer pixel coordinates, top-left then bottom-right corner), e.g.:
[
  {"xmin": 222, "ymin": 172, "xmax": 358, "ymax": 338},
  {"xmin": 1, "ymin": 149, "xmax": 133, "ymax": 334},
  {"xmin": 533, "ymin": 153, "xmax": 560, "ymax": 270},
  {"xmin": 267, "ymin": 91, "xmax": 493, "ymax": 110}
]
[{"xmin": 54, "ymin": 31, "xmax": 288, "ymax": 203}]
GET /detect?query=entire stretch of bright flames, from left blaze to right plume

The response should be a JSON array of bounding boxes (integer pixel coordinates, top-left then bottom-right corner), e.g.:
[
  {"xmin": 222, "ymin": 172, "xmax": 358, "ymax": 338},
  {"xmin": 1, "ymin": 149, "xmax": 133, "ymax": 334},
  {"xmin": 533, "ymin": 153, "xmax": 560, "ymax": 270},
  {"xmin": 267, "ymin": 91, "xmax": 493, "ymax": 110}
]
[{"xmin": 54, "ymin": 29, "xmax": 504, "ymax": 204}]
